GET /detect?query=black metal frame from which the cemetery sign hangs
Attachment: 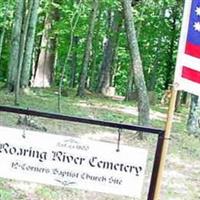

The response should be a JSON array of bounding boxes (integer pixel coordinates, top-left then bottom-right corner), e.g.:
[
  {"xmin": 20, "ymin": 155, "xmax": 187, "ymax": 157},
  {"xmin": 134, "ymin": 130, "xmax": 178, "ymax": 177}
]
[{"xmin": 0, "ymin": 106, "xmax": 165, "ymax": 200}]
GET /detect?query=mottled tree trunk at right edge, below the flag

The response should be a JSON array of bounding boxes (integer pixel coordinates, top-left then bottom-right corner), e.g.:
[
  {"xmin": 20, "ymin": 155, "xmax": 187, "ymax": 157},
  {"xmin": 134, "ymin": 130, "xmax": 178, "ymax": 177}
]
[{"xmin": 187, "ymin": 95, "xmax": 200, "ymax": 136}]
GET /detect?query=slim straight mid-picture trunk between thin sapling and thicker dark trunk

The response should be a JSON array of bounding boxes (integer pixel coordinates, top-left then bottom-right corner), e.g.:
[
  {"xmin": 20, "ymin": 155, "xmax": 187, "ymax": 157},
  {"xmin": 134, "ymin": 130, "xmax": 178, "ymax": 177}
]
[{"xmin": 77, "ymin": 0, "xmax": 99, "ymax": 97}]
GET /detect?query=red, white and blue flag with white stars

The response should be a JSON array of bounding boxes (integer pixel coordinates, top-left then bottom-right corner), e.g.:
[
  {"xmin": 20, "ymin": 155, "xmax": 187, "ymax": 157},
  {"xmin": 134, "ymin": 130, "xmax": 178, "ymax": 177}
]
[{"xmin": 174, "ymin": 0, "xmax": 200, "ymax": 95}]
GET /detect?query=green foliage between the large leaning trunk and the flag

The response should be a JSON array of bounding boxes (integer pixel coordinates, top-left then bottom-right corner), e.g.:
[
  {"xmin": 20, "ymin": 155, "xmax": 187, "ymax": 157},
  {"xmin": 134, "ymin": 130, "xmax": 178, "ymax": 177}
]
[{"xmin": 135, "ymin": 0, "xmax": 182, "ymax": 95}]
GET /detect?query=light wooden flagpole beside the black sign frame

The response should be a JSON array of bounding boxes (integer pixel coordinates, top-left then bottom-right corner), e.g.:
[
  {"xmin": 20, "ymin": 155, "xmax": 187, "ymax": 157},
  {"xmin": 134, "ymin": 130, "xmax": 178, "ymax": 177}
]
[{"xmin": 153, "ymin": 86, "xmax": 177, "ymax": 200}]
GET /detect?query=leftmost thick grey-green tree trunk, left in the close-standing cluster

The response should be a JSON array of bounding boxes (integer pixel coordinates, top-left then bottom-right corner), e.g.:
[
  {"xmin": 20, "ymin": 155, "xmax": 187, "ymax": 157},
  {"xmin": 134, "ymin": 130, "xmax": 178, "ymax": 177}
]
[{"xmin": 7, "ymin": 0, "xmax": 25, "ymax": 91}]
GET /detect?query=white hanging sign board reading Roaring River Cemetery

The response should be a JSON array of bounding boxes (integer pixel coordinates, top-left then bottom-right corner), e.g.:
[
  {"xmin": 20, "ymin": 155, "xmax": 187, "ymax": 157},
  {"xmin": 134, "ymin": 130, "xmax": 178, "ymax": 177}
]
[{"xmin": 0, "ymin": 127, "xmax": 147, "ymax": 197}]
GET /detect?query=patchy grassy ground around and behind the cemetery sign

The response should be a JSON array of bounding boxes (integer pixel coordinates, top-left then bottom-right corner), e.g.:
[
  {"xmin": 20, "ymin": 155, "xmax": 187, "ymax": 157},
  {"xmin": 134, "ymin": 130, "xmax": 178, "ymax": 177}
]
[{"xmin": 0, "ymin": 89, "xmax": 200, "ymax": 200}]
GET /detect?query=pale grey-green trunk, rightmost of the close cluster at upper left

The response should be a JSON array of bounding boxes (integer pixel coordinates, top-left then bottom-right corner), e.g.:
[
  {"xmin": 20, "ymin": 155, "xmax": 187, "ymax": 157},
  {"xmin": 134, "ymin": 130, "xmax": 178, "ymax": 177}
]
[{"xmin": 21, "ymin": 0, "xmax": 39, "ymax": 88}]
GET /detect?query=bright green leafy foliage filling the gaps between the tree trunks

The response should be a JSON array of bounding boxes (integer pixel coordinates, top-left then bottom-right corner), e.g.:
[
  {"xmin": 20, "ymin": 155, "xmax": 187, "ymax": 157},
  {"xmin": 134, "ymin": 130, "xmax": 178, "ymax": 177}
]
[{"xmin": 0, "ymin": 0, "xmax": 183, "ymax": 97}]
